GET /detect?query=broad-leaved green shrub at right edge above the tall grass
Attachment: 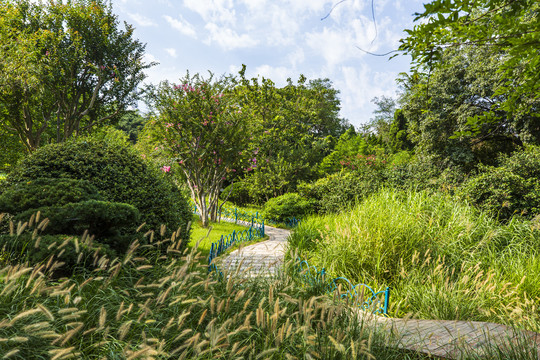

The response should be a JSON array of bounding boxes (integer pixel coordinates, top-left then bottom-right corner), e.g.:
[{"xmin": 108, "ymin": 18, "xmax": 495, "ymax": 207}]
[{"xmin": 460, "ymin": 146, "xmax": 540, "ymax": 220}]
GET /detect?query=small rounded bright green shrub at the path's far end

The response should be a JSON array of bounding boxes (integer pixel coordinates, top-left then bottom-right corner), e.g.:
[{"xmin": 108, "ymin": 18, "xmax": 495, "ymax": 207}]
[{"xmin": 262, "ymin": 193, "xmax": 313, "ymax": 222}]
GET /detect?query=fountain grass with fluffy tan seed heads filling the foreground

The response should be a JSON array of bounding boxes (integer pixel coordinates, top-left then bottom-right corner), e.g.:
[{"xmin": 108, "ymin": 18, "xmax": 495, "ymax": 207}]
[{"xmin": 0, "ymin": 212, "xmax": 434, "ymax": 360}]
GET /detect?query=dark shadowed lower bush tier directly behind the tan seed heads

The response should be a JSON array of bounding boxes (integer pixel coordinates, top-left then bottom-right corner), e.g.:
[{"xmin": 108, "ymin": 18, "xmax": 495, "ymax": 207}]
[{"xmin": 15, "ymin": 200, "xmax": 140, "ymax": 254}]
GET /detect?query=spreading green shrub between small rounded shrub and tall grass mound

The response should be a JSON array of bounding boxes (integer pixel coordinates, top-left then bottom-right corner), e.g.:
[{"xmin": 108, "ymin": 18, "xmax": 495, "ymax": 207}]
[{"xmin": 298, "ymin": 171, "xmax": 383, "ymax": 213}]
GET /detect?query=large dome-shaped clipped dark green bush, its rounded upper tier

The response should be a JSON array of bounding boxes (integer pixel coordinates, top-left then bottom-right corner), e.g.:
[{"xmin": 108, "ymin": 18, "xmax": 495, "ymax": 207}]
[{"xmin": 7, "ymin": 139, "xmax": 191, "ymax": 242}]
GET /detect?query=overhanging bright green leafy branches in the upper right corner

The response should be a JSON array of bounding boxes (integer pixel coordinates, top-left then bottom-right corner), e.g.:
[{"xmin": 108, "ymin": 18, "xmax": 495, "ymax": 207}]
[{"xmin": 400, "ymin": 0, "xmax": 540, "ymax": 134}]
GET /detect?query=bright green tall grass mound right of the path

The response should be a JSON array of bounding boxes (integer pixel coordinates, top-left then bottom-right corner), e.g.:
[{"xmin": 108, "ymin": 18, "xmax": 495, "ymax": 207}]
[{"xmin": 290, "ymin": 189, "xmax": 540, "ymax": 328}]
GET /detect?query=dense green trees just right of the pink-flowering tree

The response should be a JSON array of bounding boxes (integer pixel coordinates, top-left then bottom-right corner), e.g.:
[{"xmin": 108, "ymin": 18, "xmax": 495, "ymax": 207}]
[{"xmin": 235, "ymin": 67, "xmax": 349, "ymax": 203}]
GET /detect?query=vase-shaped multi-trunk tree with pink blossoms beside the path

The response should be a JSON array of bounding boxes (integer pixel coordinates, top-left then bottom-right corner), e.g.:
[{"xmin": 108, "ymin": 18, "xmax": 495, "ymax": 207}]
[{"xmin": 148, "ymin": 73, "xmax": 249, "ymax": 227}]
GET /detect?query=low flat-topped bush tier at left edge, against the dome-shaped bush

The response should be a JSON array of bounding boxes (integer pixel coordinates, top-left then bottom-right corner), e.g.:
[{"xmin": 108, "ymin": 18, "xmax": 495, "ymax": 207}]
[{"xmin": 0, "ymin": 178, "xmax": 102, "ymax": 214}]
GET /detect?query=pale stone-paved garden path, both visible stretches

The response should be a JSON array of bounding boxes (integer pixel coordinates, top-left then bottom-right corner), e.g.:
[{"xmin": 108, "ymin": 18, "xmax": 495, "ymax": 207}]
[{"xmin": 220, "ymin": 226, "xmax": 540, "ymax": 360}]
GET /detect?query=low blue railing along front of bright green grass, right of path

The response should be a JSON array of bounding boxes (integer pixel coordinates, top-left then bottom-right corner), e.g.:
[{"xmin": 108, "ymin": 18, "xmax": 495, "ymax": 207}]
[{"xmin": 297, "ymin": 259, "xmax": 390, "ymax": 315}]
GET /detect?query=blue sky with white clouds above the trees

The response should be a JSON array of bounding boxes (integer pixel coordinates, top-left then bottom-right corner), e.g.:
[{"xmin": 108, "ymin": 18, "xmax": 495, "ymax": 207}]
[{"xmin": 113, "ymin": 0, "xmax": 423, "ymax": 127}]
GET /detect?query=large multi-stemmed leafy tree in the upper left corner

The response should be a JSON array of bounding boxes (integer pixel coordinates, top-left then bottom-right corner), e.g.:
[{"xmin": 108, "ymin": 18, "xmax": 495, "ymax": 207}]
[{"xmin": 0, "ymin": 0, "xmax": 152, "ymax": 152}]
